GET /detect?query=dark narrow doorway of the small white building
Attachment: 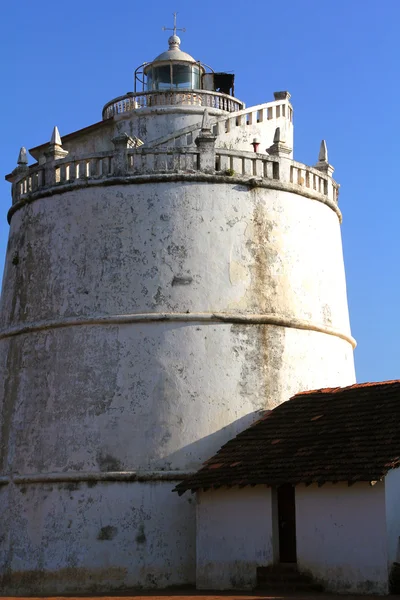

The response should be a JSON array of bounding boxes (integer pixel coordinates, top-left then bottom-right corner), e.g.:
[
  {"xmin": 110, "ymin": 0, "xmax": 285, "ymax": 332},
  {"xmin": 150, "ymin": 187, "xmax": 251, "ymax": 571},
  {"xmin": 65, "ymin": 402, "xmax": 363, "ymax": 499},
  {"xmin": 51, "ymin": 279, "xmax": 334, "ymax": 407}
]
[{"xmin": 277, "ymin": 483, "xmax": 297, "ymax": 563}]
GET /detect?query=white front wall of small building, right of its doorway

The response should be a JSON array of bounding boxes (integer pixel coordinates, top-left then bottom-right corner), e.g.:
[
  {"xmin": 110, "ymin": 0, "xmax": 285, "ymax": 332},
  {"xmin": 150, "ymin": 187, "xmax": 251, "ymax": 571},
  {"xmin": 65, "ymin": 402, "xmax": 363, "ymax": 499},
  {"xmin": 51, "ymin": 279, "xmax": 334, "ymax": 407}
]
[{"xmin": 296, "ymin": 483, "xmax": 388, "ymax": 594}]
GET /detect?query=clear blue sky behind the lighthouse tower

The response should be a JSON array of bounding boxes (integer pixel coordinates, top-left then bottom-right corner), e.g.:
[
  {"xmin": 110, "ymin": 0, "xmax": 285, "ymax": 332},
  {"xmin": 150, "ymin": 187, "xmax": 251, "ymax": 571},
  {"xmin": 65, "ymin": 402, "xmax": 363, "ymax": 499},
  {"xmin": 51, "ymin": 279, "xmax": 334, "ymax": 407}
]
[{"xmin": 0, "ymin": 0, "xmax": 400, "ymax": 381}]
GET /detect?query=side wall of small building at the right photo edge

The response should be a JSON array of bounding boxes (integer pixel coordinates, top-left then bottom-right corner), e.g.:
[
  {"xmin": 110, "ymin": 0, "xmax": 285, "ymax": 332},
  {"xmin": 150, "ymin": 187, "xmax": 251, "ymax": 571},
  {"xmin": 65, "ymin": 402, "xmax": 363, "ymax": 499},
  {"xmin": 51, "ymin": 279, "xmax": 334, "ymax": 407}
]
[{"xmin": 385, "ymin": 469, "xmax": 400, "ymax": 571}]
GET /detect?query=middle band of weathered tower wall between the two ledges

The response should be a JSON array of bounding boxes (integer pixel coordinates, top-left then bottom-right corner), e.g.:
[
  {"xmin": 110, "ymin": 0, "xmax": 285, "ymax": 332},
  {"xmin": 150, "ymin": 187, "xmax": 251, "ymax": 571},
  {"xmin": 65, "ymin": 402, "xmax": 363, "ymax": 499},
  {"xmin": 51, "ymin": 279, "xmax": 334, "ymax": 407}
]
[{"xmin": 0, "ymin": 323, "xmax": 351, "ymax": 475}]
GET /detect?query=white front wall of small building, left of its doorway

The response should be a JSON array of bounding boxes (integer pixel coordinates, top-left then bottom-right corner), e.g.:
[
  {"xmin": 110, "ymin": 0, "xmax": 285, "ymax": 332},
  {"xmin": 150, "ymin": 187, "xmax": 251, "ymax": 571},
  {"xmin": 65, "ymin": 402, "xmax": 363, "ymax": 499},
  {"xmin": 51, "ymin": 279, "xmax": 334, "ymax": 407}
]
[{"xmin": 196, "ymin": 486, "xmax": 273, "ymax": 590}]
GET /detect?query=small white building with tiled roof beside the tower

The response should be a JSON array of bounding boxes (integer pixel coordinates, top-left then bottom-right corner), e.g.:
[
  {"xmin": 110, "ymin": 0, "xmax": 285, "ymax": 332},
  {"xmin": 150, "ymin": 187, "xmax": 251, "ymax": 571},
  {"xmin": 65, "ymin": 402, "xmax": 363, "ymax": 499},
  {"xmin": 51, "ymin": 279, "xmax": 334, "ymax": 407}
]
[{"xmin": 176, "ymin": 381, "xmax": 400, "ymax": 594}]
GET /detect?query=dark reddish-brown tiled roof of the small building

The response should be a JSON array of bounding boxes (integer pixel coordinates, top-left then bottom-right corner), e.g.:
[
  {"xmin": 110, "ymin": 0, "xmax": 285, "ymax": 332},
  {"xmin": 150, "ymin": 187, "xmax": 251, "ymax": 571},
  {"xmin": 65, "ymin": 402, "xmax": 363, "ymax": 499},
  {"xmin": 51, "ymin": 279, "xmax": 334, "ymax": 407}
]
[{"xmin": 175, "ymin": 380, "xmax": 400, "ymax": 494}]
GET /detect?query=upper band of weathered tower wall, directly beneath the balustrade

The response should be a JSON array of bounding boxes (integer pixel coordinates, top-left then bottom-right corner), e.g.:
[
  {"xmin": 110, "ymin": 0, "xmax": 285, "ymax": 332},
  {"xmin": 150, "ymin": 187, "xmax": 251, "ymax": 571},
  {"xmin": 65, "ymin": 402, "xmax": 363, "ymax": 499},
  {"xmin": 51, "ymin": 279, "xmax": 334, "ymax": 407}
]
[{"xmin": 1, "ymin": 182, "xmax": 350, "ymax": 334}]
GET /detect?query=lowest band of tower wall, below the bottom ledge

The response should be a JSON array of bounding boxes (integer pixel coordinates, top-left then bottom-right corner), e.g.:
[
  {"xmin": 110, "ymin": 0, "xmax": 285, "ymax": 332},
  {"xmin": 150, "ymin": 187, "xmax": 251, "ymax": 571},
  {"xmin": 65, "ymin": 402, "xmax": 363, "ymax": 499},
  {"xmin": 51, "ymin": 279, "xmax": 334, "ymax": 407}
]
[{"xmin": 0, "ymin": 482, "xmax": 195, "ymax": 595}]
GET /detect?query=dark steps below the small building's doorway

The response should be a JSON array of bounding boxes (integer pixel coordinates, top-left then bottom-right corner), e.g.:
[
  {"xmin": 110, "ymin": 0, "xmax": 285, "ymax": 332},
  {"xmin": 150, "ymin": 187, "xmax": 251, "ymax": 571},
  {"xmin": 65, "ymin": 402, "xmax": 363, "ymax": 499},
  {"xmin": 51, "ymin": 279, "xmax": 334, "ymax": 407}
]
[{"xmin": 257, "ymin": 563, "xmax": 323, "ymax": 594}]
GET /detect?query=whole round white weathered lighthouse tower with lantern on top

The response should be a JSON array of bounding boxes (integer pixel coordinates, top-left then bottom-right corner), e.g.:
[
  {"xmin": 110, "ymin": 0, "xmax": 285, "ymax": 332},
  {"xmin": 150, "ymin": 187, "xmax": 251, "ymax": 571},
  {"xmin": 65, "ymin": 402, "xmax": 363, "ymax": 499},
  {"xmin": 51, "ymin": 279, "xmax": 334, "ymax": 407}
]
[{"xmin": 0, "ymin": 22, "xmax": 355, "ymax": 594}]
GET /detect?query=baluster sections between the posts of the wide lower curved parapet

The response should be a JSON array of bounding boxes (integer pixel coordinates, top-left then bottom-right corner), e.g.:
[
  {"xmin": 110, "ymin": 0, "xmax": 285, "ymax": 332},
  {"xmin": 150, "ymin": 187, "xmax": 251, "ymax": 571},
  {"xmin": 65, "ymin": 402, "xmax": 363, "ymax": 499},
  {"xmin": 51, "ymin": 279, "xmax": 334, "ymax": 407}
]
[{"xmin": 13, "ymin": 147, "xmax": 338, "ymax": 210}]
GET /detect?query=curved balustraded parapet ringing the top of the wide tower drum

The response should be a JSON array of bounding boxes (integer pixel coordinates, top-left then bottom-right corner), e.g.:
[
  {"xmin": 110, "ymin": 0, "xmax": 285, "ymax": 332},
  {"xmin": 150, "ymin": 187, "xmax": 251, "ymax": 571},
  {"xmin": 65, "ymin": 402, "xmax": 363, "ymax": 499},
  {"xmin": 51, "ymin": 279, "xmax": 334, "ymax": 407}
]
[{"xmin": 9, "ymin": 146, "xmax": 341, "ymax": 219}]
